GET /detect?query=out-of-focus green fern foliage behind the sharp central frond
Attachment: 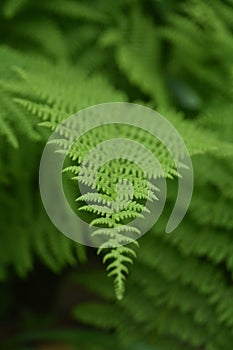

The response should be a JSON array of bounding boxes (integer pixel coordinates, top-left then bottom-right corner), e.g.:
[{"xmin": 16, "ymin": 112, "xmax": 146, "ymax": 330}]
[{"xmin": 0, "ymin": 0, "xmax": 233, "ymax": 350}]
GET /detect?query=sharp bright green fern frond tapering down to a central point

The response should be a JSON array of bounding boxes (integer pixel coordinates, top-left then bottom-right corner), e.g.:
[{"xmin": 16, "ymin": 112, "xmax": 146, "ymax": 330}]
[{"xmin": 0, "ymin": 43, "xmax": 233, "ymax": 299}]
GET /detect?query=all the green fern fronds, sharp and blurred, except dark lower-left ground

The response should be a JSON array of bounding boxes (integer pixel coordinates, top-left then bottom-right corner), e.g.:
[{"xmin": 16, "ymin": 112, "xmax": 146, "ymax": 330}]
[{"xmin": 0, "ymin": 0, "xmax": 233, "ymax": 350}]
